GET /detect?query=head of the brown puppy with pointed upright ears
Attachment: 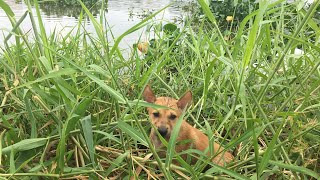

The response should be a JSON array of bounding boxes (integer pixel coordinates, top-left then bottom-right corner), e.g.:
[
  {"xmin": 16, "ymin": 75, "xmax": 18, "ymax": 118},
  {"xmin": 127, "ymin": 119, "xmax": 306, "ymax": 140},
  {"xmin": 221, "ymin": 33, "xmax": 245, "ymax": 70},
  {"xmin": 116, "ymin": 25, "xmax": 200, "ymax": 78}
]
[{"xmin": 143, "ymin": 85, "xmax": 192, "ymax": 139}]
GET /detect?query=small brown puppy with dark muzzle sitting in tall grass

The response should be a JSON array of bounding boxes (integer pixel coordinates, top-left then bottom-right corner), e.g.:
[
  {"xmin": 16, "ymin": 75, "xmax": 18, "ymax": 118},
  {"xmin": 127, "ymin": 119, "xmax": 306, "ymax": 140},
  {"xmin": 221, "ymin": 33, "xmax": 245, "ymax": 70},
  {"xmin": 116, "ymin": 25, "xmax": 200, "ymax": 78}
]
[{"xmin": 143, "ymin": 85, "xmax": 233, "ymax": 166}]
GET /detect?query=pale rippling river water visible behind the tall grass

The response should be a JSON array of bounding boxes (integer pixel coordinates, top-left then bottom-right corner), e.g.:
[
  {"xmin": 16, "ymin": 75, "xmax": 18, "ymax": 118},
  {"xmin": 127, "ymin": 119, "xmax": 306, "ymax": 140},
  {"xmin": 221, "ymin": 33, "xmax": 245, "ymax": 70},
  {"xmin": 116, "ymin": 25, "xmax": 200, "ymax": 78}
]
[{"xmin": 0, "ymin": 0, "xmax": 190, "ymax": 51}]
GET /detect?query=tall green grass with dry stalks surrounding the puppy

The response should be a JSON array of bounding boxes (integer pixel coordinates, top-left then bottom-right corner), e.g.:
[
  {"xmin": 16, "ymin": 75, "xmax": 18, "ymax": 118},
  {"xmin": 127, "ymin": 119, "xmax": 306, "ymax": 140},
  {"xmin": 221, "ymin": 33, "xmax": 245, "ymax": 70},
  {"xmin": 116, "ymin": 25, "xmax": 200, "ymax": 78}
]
[{"xmin": 0, "ymin": 0, "xmax": 320, "ymax": 179}]
